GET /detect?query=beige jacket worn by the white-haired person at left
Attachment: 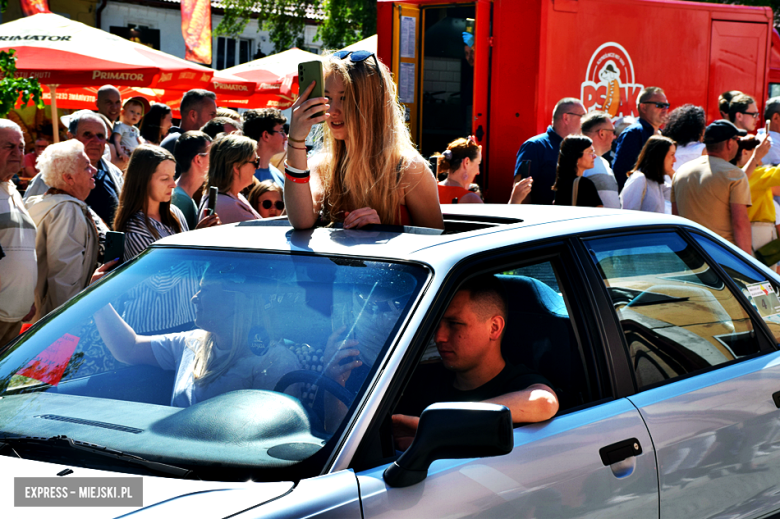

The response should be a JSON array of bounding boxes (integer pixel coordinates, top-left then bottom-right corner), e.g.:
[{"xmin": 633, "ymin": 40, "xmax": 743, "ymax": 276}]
[{"xmin": 25, "ymin": 194, "xmax": 99, "ymax": 322}]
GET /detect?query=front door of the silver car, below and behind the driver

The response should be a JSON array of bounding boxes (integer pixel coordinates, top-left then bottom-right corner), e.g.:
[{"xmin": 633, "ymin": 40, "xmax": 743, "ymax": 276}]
[{"xmin": 358, "ymin": 246, "xmax": 658, "ymax": 519}]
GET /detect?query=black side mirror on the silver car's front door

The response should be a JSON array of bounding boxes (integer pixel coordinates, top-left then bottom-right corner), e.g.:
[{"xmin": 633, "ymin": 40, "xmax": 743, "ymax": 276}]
[{"xmin": 384, "ymin": 402, "xmax": 514, "ymax": 488}]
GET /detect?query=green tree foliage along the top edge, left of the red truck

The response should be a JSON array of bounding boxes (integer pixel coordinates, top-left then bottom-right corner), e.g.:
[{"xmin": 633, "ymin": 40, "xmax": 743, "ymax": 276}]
[{"xmin": 214, "ymin": 0, "xmax": 376, "ymax": 52}]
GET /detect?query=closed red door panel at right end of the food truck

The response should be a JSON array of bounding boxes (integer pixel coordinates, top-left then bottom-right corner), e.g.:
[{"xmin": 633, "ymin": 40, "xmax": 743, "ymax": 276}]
[{"xmin": 707, "ymin": 20, "xmax": 770, "ymax": 121}]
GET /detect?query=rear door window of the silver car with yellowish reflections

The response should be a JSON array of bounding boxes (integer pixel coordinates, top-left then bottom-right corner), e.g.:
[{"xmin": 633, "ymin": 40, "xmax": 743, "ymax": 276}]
[{"xmin": 585, "ymin": 232, "xmax": 759, "ymax": 389}]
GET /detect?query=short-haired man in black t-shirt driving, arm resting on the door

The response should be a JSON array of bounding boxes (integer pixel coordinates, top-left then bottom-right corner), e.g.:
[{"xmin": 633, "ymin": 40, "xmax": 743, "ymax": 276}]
[{"xmin": 392, "ymin": 275, "xmax": 558, "ymax": 450}]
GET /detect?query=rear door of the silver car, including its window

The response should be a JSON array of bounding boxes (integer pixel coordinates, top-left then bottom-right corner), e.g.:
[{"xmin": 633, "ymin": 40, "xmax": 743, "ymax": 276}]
[{"xmin": 584, "ymin": 231, "xmax": 780, "ymax": 518}]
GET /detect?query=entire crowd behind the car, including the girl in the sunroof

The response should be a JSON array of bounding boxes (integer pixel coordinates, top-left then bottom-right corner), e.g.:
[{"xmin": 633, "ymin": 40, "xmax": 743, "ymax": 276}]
[{"xmin": 0, "ymin": 52, "xmax": 780, "ymax": 354}]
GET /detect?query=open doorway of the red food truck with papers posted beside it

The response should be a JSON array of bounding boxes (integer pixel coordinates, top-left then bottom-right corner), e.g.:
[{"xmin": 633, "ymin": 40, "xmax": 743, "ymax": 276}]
[{"xmin": 379, "ymin": 0, "xmax": 491, "ymax": 165}]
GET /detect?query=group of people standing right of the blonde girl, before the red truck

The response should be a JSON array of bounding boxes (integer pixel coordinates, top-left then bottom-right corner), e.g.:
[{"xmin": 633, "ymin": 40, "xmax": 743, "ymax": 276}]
[{"xmin": 510, "ymin": 87, "xmax": 780, "ymax": 270}]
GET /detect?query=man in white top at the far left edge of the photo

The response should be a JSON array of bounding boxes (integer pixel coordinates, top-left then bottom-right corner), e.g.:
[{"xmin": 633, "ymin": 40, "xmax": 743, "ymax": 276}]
[{"xmin": 0, "ymin": 119, "xmax": 38, "ymax": 347}]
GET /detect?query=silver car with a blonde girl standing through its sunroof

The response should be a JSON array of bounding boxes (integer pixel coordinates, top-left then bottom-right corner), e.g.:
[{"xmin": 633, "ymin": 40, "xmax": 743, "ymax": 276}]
[{"xmin": 0, "ymin": 205, "xmax": 780, "ymax": 519}]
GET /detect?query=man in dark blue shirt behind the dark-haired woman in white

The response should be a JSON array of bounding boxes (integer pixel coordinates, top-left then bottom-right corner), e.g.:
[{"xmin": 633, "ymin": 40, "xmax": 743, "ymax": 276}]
[{"xmin": 612, "ymin": 87, "xmax": 669, "ymax": 190}]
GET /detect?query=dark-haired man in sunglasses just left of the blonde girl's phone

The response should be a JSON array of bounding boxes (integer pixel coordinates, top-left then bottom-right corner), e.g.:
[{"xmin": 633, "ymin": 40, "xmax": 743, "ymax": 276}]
[{"xmin": 244, "ymin": 108, "xmax": 287, "ymax": 186}]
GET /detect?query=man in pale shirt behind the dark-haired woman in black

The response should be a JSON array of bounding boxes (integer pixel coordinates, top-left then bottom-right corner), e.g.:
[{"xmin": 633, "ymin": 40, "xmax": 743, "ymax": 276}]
[{"xmin": 582, "ymin": 112, "xmax": 620, "ymax": 209}]
